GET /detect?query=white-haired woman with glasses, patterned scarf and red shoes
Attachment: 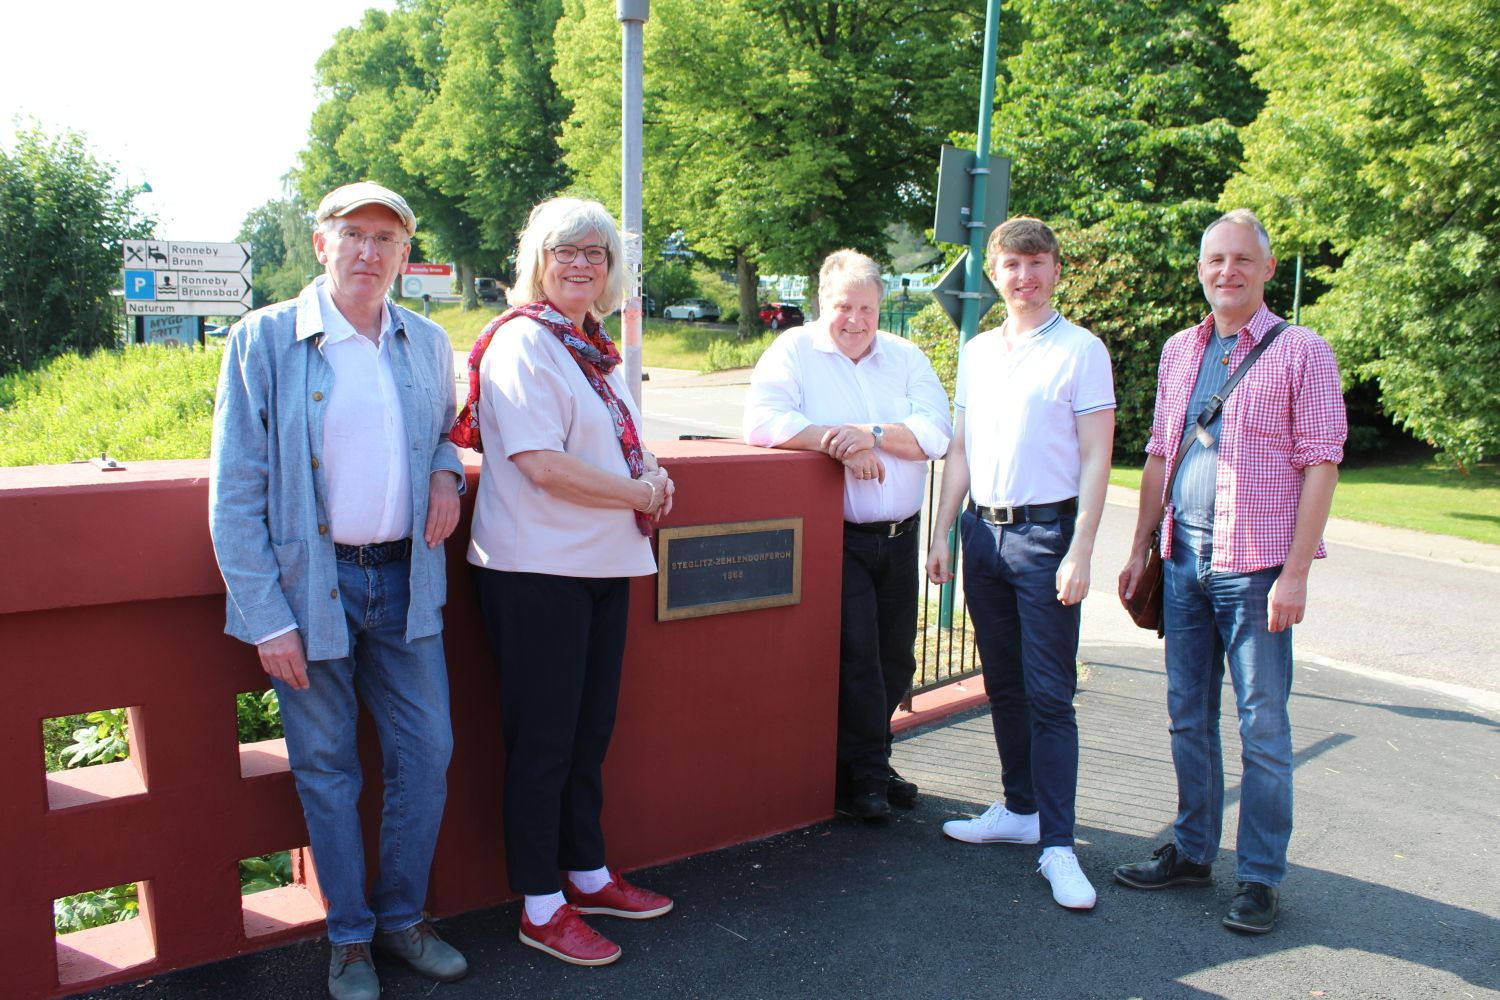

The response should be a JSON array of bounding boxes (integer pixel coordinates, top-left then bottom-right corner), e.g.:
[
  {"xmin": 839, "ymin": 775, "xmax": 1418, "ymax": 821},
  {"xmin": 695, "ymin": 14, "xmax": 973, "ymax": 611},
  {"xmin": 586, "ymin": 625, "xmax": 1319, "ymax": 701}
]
[{"xmin": 453, "ymin": 198, "xmax": 674, "ymax": 966}]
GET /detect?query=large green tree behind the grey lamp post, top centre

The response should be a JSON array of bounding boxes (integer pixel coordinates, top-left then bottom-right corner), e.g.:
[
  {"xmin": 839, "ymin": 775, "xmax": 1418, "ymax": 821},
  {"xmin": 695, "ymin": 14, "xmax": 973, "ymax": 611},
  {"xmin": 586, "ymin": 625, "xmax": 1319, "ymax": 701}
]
[{"xmin": 555, "ymin": 0, "xmax": 983, "ymax": 334}]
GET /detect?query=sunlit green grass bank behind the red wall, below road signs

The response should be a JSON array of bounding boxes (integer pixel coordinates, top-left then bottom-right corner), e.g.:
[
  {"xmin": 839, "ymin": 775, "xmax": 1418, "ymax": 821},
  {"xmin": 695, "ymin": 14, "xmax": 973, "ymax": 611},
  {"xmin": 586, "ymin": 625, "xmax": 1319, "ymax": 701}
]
[{"xmin": 0, "ymin": 346, "xmax": 221, "ymax": 466}]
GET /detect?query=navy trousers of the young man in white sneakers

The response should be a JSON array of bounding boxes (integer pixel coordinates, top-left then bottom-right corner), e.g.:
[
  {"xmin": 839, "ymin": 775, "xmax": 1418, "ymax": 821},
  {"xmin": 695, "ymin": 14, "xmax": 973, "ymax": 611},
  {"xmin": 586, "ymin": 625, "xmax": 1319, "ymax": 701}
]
[{"xmin": 960, "ymin": 511, "xmax": 1082, "ymax": 847}]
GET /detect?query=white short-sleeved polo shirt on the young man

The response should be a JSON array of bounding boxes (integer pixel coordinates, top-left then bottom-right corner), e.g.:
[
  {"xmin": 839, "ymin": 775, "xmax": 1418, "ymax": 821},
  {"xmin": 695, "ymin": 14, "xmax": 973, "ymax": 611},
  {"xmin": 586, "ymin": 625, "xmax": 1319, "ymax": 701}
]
[{"xmin": 954, "ymin": 315, "xmax": 1115, "ymax": 507}]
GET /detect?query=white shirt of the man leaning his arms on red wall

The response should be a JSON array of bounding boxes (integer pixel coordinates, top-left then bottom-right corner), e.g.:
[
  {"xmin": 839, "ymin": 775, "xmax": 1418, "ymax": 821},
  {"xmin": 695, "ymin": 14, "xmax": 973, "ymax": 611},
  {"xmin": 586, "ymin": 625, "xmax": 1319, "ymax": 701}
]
[{"xmin": 744, "ymin": 322, "xmax": 953, "ymax": 523}]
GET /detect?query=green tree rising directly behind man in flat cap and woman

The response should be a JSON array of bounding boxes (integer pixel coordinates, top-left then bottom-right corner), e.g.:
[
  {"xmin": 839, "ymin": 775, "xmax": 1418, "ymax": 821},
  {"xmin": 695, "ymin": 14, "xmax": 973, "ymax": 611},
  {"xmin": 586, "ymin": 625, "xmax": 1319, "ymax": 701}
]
[{"xmin": 297, "ymin": 0, "xmax": 566, "ymax": 306}]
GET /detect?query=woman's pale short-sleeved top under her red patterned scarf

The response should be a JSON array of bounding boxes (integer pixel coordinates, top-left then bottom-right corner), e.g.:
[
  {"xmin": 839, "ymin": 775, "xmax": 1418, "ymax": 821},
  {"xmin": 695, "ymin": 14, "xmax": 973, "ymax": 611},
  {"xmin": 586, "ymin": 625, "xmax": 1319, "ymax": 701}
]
[{"xmin": 468, "ymin": 316, "xmax": 656, "ymax": 577}]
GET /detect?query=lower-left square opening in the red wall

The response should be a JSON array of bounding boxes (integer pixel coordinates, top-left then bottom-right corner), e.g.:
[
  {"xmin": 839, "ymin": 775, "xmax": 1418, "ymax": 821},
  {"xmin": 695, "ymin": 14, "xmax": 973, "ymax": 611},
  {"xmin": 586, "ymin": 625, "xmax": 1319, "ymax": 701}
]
[{"xmin": 53, "ymin": 882, "xmax": 156, "ymax": 987}]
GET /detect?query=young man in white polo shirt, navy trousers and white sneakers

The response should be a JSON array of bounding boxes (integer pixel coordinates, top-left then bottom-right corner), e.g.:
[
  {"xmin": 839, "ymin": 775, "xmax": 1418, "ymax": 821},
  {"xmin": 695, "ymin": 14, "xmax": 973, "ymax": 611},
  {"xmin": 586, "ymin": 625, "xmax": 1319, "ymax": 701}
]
[{"xmin": 927, "ymin": 217, "xmax": 1115, "ymax": 910}]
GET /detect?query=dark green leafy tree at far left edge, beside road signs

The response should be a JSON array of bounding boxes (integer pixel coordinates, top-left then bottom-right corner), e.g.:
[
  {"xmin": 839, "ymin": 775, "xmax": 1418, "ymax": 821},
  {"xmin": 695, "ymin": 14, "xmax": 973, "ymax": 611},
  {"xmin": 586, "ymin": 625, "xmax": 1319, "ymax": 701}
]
[{"xmin": 0, "ymin": 124, "xmax": 156, "ymax": 375}]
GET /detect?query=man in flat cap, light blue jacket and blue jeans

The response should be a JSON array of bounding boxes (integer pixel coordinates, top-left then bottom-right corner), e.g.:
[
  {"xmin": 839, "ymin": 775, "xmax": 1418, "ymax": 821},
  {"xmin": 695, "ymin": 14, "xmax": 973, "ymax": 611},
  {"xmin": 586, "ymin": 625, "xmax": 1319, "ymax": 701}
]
[{"xmin": 209, "ymin": 181, "xmax": 468, "ymax": 1000}]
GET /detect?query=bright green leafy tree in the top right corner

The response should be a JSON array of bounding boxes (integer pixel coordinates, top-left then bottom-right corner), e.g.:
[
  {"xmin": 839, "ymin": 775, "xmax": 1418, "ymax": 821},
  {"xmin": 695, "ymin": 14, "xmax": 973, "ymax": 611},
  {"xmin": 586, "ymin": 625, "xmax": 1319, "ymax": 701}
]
[{"xmin": 1223, "ymin": 0, "xmax": 1500, "ymax": 465}]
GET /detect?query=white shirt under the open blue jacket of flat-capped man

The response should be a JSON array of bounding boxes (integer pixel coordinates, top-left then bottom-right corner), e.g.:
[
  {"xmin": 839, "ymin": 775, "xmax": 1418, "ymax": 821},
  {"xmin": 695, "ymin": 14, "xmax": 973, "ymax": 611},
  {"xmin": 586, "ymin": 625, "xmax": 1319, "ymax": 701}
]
[{"xmin": 318, "ymin": 282, "xmax": 411, "ymax": 546}]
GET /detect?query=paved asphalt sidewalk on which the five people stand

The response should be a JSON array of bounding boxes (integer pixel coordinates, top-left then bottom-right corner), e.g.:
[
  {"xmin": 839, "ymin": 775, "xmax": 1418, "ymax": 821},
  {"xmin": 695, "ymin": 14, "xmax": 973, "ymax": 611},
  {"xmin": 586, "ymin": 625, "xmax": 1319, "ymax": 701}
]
[{"xmin": 92, "ymin": 643, "xmax": 1500, "ymax": 1000}]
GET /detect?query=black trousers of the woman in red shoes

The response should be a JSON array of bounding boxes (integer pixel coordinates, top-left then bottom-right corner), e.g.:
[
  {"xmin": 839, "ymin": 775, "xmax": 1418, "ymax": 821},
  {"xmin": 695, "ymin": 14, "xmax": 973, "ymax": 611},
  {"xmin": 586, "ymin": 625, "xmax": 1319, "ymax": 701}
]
[{"xmin": 476, "ymin": 570, "xmax": 630, "ymax": 895}]
